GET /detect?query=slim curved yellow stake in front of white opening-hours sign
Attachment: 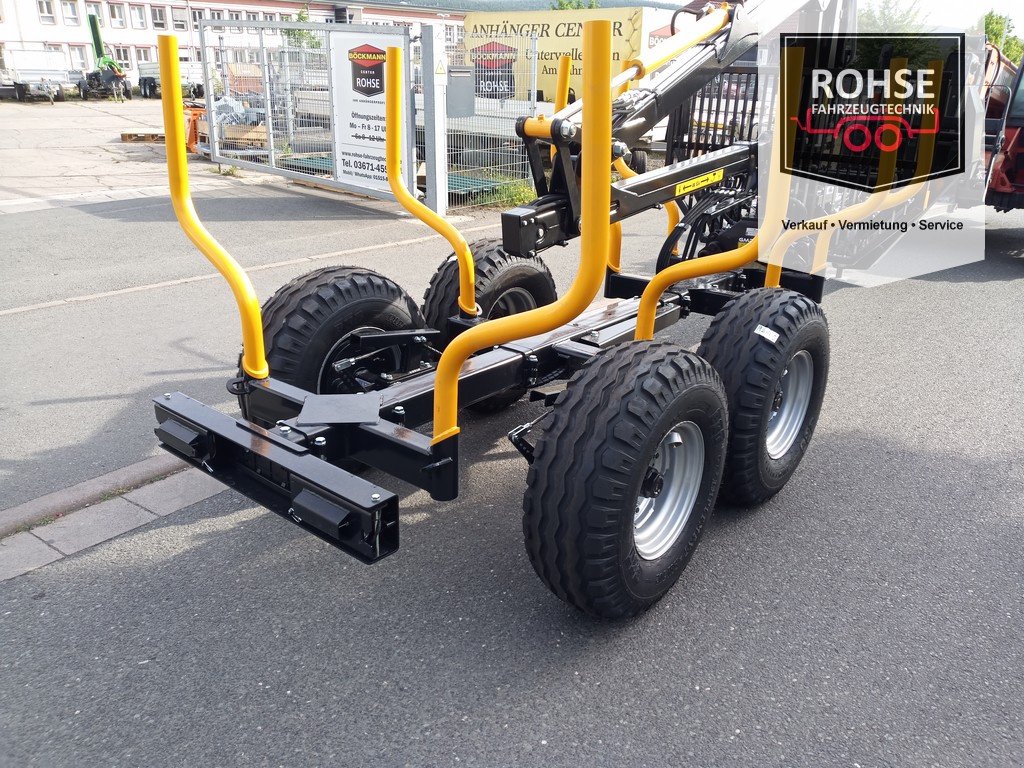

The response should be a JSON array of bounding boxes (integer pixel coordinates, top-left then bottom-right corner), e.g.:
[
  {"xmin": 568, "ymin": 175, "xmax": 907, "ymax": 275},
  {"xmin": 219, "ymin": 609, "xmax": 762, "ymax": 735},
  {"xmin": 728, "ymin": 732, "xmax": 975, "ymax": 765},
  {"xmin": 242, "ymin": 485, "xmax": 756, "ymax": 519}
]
[{"xmin": 384, "ymin": 47, "xmax": 480, "ymax": 317}]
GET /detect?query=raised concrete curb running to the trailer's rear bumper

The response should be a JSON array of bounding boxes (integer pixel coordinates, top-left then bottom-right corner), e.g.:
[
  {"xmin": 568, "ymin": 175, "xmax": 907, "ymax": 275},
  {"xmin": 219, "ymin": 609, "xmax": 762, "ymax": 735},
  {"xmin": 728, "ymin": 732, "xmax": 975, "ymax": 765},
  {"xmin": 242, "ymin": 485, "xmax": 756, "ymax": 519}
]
[{"xmin": 0, "ymin": 454, "xmax": 188, "ymax": 538}]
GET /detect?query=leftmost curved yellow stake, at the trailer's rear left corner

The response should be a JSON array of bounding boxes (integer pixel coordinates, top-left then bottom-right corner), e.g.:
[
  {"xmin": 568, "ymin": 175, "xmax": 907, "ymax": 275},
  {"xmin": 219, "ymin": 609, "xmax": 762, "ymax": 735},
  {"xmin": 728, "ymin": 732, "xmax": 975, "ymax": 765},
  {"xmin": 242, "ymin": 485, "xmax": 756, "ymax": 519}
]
[{"xmin": 158, "ymin": 35, "xmax": 269, "ymax": 379}]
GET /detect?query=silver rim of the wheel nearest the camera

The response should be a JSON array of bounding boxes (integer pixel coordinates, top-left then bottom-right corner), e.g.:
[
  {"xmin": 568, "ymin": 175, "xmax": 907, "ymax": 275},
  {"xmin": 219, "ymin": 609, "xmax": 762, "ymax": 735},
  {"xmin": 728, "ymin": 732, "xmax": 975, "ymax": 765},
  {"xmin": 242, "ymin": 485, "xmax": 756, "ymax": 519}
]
[{"xmin": 633, "ymin": 421, "xmax": 705, "ymax": 560}]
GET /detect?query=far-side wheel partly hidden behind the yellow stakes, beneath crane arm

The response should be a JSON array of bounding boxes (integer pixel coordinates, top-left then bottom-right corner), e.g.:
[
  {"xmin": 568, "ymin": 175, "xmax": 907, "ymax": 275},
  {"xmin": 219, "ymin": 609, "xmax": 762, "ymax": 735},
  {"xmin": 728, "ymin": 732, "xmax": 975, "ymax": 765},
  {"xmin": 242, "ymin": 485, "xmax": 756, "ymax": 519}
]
[{"xmin": 423, "ymin": 239, "xmax": 558, "ymax": 413}]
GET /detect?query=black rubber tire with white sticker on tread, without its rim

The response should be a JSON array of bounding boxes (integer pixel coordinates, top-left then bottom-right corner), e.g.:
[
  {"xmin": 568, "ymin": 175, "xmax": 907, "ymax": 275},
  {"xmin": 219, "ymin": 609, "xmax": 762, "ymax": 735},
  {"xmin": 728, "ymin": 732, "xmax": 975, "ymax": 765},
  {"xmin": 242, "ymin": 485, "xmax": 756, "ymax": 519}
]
[{"xmin": 697, "ymin": 288, "xmax": 828, "ymax": 507}]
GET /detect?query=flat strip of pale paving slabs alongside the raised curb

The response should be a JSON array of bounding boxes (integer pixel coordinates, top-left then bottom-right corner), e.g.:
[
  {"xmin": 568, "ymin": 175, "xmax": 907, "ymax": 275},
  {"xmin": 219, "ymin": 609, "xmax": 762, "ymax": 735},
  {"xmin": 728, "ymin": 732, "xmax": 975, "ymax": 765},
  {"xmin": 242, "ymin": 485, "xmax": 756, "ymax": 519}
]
[{"xmin": 0, "ymin": 469, "xmax": 226, "ymax": 582}]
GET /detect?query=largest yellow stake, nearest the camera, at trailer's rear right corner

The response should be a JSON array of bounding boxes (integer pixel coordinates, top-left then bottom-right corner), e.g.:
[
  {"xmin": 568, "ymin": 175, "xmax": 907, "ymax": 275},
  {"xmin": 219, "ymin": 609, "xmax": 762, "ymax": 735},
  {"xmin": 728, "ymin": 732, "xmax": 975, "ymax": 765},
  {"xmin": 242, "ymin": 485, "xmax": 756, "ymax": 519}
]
[{"xmin": 428, "ymin": 19, "xmax": 611, "ymax": 444}]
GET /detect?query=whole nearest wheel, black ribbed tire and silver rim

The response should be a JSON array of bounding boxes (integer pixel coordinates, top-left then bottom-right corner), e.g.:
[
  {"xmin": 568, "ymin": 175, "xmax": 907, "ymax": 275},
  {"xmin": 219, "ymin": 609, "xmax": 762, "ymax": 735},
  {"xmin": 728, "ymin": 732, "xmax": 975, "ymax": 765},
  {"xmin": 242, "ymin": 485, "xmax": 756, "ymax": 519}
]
[{"xmin": 522, "ymin": 341, "xmax": 729, "ymax": 618}]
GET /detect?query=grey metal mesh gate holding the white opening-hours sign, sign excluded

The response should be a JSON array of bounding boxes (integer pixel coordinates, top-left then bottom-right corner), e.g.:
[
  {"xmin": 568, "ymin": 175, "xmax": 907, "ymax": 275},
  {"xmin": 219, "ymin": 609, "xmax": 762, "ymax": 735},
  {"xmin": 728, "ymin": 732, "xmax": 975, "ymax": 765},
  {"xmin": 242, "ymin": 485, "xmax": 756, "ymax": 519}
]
[{"xmin": 198, "ymin": 19, "xmax": 408, "ymax": 197}]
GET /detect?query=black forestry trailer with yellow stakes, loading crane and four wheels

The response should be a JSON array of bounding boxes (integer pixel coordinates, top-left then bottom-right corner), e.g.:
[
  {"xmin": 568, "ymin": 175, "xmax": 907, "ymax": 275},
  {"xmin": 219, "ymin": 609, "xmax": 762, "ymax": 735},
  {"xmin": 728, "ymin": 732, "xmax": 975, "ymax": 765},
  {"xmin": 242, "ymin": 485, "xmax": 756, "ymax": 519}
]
[{"xmin": 155, "ymin": 0, "xmax": 851, "ymax": 617}]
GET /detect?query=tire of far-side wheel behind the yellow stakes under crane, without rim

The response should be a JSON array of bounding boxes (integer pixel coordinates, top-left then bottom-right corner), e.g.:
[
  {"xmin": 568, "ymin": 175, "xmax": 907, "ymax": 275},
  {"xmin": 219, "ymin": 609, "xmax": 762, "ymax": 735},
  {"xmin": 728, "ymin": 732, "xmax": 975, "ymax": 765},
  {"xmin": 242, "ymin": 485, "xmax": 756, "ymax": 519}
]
[{"xmin": 423, "ymin": 238, "xmax": 558, "ymax": 414}]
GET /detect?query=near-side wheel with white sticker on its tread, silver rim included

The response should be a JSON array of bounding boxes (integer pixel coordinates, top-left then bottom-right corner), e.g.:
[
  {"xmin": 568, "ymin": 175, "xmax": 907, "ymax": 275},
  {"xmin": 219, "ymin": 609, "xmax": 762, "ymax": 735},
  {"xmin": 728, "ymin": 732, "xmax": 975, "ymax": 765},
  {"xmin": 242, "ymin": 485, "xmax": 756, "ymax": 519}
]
[{"xmin": 697, "ymin": 288, "xmax": 828, "ymax": 506}]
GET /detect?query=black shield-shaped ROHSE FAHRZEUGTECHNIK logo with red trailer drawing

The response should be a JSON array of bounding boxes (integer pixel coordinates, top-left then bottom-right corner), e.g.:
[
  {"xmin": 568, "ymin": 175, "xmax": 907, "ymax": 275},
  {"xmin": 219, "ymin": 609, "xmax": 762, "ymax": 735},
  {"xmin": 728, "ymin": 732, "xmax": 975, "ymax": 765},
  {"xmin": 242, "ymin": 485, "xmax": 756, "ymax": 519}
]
[{"xmin": 780, "ymin": 34, "xmax": 965, "ymax": 191}]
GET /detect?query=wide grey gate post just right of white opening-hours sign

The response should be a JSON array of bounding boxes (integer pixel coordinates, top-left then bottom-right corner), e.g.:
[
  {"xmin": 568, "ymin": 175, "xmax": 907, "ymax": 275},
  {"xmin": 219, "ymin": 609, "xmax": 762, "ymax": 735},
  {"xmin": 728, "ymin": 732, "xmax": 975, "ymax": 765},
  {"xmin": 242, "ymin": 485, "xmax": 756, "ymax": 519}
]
[{"xmin": 412, "ymin": 25, "xmax": 447, "ymax": 216}]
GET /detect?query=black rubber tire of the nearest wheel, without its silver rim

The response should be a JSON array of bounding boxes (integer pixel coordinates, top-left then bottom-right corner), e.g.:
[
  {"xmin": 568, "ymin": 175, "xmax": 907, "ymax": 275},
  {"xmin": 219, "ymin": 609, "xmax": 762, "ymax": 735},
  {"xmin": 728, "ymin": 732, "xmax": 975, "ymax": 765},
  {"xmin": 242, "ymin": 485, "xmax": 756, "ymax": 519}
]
[{"xmin": 522, "ymin": 341, "xmax": 728, "ymax": 618}]
